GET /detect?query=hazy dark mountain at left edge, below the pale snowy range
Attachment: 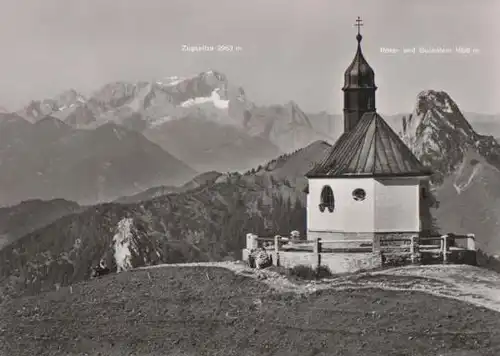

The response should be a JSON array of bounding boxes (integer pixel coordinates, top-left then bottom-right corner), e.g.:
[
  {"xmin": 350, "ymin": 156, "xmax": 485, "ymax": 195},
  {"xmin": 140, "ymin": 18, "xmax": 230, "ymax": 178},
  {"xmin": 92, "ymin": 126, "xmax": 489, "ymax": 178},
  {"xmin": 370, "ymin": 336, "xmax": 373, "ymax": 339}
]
[{"xmin": 0, "ymin": 114, "xmax": 197, "ymax": 206}]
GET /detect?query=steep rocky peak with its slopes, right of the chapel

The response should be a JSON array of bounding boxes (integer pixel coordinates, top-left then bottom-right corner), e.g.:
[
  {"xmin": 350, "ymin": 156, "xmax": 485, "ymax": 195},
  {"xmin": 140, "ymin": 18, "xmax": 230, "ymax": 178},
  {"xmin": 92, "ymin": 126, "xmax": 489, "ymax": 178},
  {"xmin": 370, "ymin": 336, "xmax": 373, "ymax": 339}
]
[{"xmin": 401, "ymin": 90, "xmax": 500, "ymax": 254}]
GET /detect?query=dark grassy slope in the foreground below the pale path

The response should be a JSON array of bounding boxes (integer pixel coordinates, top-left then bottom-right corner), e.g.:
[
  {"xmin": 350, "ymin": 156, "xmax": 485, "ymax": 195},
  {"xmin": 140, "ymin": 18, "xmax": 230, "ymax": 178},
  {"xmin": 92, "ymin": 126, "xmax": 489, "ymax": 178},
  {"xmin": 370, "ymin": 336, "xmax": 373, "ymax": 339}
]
[{"xmin": 0, "ymin": 267, "xmax": 500, "ymax": 356}]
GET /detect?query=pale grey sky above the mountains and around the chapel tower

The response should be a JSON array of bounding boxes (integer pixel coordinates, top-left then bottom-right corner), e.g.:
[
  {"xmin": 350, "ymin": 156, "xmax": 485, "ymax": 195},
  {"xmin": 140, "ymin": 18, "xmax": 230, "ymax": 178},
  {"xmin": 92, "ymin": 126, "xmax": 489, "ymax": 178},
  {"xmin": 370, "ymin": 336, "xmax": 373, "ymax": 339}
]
[{"xmin": 0, "ymin": 0, "xmax": 500, "ymax": 114}]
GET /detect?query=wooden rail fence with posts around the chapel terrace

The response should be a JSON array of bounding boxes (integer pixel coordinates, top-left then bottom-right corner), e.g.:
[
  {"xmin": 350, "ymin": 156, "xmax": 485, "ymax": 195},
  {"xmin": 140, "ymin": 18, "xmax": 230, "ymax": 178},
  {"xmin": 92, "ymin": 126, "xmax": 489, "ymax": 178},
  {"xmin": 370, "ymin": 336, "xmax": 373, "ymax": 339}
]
[{"xmin": 247, "ymin": 234, "xmax": 476, "ymax": 263}]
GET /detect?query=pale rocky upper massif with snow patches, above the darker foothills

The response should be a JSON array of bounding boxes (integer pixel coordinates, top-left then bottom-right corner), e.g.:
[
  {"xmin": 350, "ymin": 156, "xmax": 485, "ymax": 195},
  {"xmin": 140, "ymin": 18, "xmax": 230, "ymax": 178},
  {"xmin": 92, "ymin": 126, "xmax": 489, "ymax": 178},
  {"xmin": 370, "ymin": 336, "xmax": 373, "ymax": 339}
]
[{"xmin": 13, "ymin": 69, "xmax": 325, "ymax": 152}]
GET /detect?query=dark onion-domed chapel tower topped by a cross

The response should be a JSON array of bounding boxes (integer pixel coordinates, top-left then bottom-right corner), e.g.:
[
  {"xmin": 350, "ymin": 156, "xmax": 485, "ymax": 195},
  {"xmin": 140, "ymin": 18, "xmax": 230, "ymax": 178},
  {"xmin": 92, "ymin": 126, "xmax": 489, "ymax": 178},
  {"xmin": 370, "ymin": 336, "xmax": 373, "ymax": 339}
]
[{"xmin": 342, "ymin": 16, "xmax": 377, "ymax": 132}]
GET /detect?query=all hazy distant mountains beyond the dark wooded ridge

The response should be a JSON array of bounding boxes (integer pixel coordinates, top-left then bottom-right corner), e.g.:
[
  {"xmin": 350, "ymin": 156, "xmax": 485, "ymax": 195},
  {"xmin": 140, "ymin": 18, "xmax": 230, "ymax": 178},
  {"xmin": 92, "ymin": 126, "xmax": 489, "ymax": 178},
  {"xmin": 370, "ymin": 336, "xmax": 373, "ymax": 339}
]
[{"xmin": 5, "ymin": 70, "xmax": 500, "ymax": 206}]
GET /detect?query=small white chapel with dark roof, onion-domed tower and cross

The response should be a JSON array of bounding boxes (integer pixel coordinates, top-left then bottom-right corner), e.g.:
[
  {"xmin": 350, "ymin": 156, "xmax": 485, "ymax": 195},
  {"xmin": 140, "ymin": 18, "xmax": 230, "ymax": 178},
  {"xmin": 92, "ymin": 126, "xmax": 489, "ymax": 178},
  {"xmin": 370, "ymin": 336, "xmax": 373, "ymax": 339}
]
[{"xmin": 306, "ymin": 17, "xmax": 431, "ymax": 241}]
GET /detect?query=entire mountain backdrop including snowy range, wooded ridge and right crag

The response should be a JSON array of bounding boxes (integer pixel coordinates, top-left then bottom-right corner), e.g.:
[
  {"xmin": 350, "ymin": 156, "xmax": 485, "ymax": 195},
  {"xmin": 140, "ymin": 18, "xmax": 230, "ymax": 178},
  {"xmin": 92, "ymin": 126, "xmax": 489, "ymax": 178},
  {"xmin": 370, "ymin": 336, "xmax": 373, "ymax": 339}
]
[{"xmin": 0, "ymin": 71, "xmax": 500, "ymax": 295}]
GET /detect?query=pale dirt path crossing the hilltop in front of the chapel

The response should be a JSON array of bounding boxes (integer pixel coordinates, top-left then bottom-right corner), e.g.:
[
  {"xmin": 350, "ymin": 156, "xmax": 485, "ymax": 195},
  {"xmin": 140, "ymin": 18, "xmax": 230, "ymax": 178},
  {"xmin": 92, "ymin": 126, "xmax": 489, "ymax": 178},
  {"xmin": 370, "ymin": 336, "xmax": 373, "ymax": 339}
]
[{"xmin": 138, "ymin": 262, "xmax": 500, "ymax": 312}]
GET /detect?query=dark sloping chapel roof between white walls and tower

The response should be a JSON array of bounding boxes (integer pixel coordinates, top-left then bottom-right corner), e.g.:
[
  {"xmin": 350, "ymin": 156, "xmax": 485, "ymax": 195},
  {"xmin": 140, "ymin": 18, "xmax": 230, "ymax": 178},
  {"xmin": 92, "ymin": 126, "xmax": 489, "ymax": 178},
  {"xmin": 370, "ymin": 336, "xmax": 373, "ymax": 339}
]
[{"xmin": 306, "ymin": 112, "xmax": 432, "ymax": 178}]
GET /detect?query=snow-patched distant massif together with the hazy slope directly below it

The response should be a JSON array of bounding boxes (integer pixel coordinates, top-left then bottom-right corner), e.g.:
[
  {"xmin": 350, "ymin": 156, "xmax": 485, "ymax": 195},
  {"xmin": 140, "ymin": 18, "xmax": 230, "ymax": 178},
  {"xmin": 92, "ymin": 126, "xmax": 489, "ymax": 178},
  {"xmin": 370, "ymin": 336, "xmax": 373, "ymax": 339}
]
[{"xmin": 12, "ymin": 70, "xmax": 331, "ymax": 172}]
